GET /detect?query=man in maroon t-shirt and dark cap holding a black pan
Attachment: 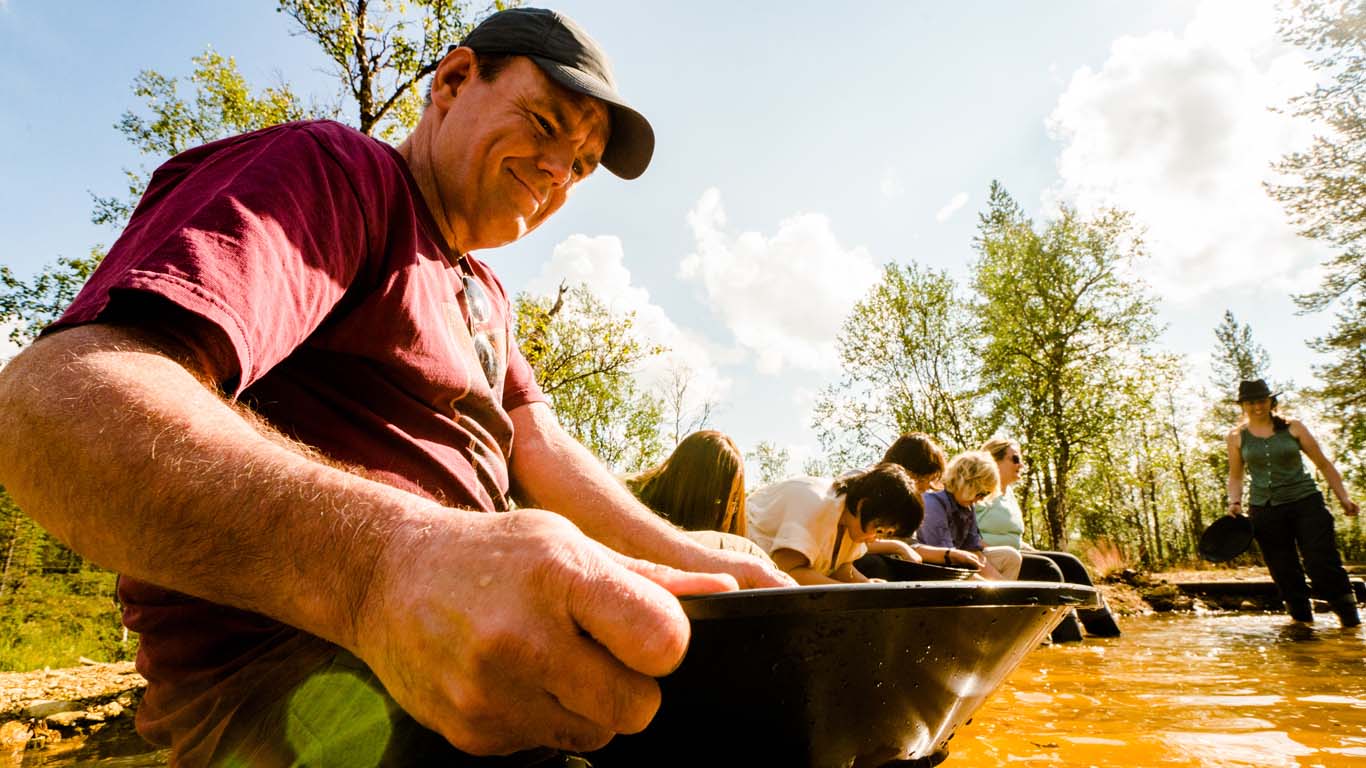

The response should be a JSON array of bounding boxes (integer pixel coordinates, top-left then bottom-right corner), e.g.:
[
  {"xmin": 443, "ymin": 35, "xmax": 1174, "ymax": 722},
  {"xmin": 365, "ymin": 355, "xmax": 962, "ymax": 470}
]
[{"xmin": 0, "ymin": 8, "xmax": 790, "ymax": 765}]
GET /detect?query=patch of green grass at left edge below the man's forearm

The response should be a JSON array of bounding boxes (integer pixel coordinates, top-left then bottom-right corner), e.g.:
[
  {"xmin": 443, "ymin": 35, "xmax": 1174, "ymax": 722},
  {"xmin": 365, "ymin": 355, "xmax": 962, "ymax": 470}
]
[{"xmin": 0, "ymin": 570, "xmax": 138, "ymax": 672}]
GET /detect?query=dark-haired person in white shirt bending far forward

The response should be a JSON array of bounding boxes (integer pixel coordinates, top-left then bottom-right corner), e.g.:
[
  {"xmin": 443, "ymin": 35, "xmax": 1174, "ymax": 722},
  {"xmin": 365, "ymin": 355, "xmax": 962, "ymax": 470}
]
[{"xmin": 747, "ymin": 463, "xmax": 925, "ymax": 584}]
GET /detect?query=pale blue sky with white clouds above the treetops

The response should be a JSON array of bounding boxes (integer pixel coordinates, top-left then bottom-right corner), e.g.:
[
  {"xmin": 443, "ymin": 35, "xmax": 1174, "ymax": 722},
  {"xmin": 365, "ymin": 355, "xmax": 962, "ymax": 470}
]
[{"xmin": 0, "ymin": 0, "xmax": 1344, "ymax": 469}]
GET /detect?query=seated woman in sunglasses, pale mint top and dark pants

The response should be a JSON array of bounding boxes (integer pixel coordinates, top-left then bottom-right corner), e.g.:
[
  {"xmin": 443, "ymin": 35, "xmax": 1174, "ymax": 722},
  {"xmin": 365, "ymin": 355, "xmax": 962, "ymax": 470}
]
[{"xmin": 975, "ymin": 437, "xmax": 1120, "ymax": 634}]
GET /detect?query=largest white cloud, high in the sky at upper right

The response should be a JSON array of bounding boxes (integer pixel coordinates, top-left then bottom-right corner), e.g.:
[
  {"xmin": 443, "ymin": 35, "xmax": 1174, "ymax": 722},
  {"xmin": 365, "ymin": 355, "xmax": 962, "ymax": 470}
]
[{"xmin": 1049, "ymin": 0, "xmax": 1322, "ymax": 299}]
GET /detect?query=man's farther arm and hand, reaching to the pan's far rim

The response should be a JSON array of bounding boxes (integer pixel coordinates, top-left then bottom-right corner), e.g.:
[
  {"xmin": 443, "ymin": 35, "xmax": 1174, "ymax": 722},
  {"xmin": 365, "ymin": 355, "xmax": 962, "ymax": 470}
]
[{"xmin": 510, "ymin": 403, "xmax": 792, "ymax": 586}]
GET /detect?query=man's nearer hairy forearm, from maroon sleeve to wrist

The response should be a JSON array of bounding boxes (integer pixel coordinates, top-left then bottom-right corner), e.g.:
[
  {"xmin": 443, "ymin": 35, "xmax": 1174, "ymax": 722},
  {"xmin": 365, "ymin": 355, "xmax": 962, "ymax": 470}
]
[{"xmin": 0, "ymin": 325, "xmax": 440, "ymax": 646}]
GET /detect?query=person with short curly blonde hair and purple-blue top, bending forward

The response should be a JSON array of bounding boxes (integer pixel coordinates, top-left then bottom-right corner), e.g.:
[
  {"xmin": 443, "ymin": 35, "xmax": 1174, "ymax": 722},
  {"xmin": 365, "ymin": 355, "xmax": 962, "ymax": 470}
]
[{"xmin": 915, "ymin": 451, "xmax": 1020, "ymax": 581}]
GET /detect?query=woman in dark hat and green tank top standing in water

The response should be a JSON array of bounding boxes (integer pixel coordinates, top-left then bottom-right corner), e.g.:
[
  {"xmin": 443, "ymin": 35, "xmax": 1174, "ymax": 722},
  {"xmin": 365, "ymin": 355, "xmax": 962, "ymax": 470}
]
[{"xmin": 1227, "ymin": 379, "xmax": 1361, "ymax": 627}]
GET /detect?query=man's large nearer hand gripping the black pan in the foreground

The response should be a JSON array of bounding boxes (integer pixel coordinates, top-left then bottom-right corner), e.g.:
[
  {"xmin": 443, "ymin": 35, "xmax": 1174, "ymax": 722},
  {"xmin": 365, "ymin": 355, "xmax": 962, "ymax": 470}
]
[{"xmin": 354, "ymin": 510, "xmax": 736, "ymax": 754}]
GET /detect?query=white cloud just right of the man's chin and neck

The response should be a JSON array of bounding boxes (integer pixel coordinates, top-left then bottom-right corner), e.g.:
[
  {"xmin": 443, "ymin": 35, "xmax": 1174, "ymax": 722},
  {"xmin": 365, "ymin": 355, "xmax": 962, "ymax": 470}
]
[{"xmin": 527, "ymin": 235, "xmax": 735, "ymax": 410}]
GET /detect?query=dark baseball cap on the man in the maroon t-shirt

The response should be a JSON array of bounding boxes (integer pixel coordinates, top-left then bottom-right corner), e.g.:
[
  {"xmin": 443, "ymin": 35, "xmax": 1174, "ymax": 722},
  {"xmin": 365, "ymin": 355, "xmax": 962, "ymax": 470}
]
[{"xmin": 460, "ymin": 8, "xmax": 654, "ymax": 179}]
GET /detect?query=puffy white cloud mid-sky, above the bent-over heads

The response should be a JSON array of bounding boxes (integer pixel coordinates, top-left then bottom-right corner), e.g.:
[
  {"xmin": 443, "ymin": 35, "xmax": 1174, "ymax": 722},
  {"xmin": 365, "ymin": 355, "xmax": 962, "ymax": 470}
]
[{"xmin": 679, "ymin": 189, "xmax": 878, "ymax": 373}]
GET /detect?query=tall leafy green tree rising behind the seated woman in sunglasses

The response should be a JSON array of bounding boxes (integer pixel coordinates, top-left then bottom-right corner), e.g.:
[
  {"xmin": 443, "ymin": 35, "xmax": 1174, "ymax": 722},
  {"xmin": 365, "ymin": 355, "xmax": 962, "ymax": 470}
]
[{"xmin": 973, "ymin": 182, "xmax": 1157, "ymax": 547}]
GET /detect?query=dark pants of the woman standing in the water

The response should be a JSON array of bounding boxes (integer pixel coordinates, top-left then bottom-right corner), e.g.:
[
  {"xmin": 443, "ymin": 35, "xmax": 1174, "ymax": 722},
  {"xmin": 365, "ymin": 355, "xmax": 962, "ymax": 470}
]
[{"xmin": 1251, "ymin": 493, "xmax": 1352, "ymax": 618}]
